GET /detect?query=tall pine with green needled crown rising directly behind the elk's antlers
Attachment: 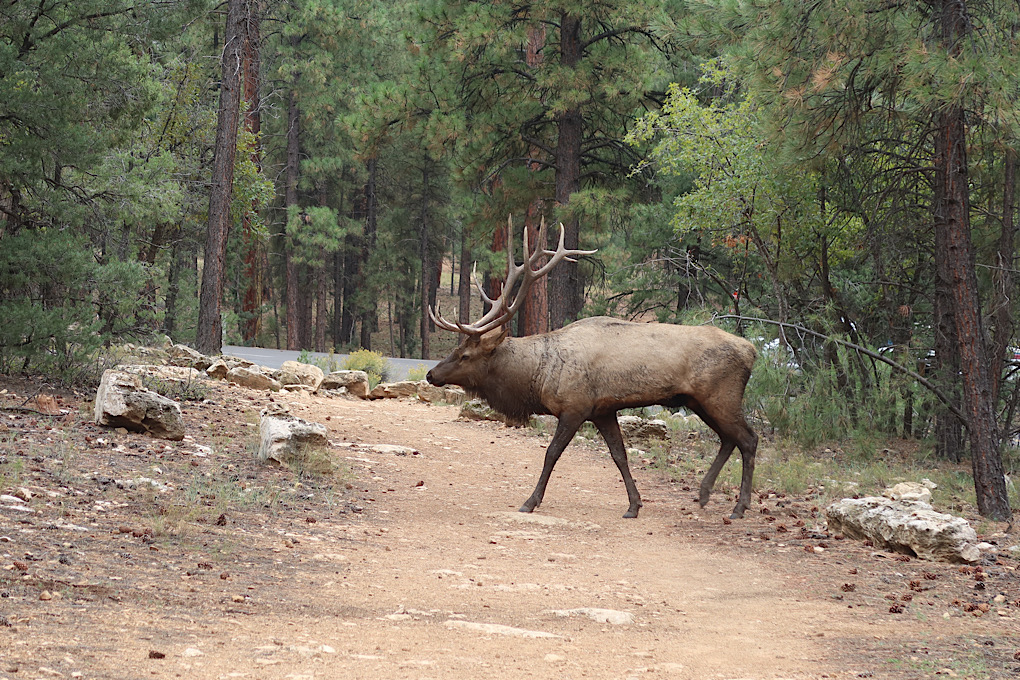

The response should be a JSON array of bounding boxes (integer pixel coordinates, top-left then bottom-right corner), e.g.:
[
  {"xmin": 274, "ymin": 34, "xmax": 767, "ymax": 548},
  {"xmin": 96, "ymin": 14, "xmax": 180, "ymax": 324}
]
[{"xmin": 423, "ymin": 0, "xmax": 676, "ymax": 327}]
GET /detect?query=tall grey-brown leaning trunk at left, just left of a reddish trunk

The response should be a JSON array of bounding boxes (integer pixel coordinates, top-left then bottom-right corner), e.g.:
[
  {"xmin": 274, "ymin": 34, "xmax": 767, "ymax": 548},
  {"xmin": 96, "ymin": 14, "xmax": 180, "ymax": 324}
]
[{"xmin": 195, "ymin": 0, "xmax": 247, "ymax": 355}]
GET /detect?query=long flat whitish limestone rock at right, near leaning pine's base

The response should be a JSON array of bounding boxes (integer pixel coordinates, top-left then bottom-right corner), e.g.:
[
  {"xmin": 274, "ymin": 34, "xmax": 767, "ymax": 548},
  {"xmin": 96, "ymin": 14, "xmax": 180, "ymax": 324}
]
[{"xmin": 825, "ymin": 496, "xmax": 981, "ymax": 562}]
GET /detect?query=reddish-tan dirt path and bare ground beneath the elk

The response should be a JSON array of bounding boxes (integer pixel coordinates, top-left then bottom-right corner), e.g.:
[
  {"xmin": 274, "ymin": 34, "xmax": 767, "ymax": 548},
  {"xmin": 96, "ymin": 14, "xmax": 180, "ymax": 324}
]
[{"xmin": 0, "ymin": 383, "xmax": 1020, "ymax": 680}]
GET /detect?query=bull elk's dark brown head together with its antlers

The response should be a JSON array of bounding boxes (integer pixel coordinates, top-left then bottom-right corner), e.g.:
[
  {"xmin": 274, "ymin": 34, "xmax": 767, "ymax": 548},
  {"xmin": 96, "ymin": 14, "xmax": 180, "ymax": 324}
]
[{"xmin": 425, "ymin": 216, "xmax": 596, "ymax": 389}]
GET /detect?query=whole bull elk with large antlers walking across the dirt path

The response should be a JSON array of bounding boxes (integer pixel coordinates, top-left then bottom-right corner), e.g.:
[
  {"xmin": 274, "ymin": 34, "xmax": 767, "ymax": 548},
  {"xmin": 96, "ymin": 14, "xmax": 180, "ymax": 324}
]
[{"xmin": 426, "ymin": 218, "xmax": 758, "ymax": 518}]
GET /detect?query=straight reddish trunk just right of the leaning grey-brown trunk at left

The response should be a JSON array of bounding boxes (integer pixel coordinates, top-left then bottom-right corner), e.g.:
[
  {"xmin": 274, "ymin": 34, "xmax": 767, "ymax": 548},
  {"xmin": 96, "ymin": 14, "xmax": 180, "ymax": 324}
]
[{"xmin": 241, "ymin": 3, "xmax": 262, "ymax": 345}]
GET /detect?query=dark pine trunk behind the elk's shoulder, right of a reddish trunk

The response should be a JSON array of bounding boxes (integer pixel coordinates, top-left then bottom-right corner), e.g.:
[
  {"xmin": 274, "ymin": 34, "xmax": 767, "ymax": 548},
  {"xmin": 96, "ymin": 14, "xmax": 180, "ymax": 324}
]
[{"xmin": 549, "ymin": 13, "xmax": 584, "ymax": 330}]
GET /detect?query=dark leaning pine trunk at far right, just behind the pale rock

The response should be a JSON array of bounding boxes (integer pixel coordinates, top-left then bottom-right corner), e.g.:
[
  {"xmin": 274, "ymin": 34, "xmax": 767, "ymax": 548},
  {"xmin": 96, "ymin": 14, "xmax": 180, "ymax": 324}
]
[{"xmin": 934, "ymin": 0, "xmax": 1012, "ymax": 521}]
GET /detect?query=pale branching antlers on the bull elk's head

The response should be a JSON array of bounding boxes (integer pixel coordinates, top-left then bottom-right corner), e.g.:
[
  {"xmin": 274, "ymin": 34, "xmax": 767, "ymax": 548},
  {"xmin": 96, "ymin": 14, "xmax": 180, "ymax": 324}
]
[{"xmin": 428, "ymin": 215, "xmax": 598, "ymax": 335}]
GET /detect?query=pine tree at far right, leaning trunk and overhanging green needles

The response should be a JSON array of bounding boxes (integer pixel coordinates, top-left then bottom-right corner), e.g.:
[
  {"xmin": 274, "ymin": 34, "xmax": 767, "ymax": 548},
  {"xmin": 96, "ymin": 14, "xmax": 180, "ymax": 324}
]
[{"xmin": 706, "ymin": 0, "xmax": 1020, "ymax": 519}]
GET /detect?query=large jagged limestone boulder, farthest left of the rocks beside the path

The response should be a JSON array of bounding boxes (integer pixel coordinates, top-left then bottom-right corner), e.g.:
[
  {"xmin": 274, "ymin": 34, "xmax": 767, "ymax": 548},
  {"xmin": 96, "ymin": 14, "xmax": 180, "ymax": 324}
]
[{"xmin": 95, "ymin": 369, "xmax": 185, "ymax": 441}]
